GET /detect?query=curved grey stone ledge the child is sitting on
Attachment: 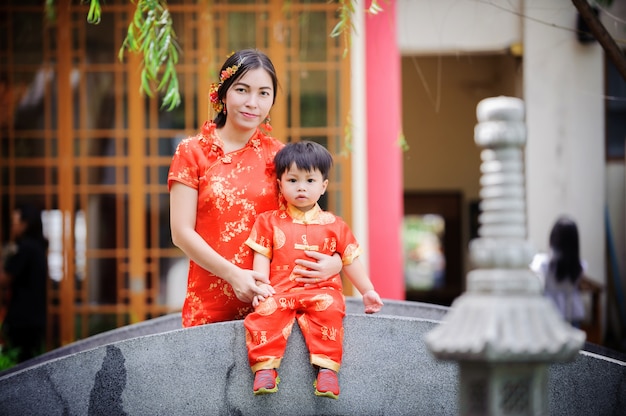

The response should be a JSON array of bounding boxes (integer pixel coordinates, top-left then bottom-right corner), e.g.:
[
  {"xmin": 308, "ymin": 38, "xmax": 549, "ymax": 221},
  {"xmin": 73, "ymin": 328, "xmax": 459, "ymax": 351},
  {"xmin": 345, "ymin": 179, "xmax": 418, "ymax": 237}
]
[{"xmin": 0, "ymin": 301, "xmax": 626, "ymax": 416}]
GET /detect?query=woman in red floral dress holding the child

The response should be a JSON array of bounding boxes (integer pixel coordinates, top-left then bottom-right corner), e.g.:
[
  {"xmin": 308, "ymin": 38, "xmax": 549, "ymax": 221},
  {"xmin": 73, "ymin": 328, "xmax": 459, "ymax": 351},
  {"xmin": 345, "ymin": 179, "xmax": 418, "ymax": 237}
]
[{"xmin": 168, "ymin": 49, "xmax": 341, "ymax": 327}]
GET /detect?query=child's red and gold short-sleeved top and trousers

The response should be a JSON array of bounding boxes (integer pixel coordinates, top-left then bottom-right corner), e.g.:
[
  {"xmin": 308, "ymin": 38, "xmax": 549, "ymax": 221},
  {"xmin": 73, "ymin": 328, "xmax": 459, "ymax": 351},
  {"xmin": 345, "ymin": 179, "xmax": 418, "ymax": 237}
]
[{"xmin": 244, "ymin": 205, "xmax": 362, "ymax": 372}]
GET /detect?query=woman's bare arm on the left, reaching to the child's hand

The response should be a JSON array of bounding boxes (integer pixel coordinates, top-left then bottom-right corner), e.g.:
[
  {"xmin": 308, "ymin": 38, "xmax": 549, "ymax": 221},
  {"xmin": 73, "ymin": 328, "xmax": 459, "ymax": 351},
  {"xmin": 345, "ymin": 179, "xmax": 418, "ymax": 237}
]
[{"xmin": 170, "ymin": 182, "xmax": 270, "ymax": 302}]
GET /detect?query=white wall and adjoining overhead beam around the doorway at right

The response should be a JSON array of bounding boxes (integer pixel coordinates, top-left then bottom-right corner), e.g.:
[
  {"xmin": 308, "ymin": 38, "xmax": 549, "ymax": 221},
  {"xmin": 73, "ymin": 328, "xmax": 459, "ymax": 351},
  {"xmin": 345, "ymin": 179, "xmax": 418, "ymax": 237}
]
[{"xmin": 397, "ymin": 0, "xmax": 606, "ymax": 282}]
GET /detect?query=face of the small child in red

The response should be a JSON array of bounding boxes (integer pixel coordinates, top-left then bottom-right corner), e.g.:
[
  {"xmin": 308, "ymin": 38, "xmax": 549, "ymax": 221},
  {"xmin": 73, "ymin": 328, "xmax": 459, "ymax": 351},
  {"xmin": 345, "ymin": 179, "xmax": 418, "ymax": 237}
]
[{"xmin": 278, "ymin": 163, "xmax": 328, "ymax": 212}]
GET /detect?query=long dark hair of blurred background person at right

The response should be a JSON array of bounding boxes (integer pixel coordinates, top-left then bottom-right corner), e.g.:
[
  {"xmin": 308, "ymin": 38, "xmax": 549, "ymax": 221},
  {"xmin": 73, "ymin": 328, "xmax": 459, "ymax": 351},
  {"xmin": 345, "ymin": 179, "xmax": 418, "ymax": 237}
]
[{"xmin": 548, "ymin": 217, "xmax": 582, "ymax": 282}]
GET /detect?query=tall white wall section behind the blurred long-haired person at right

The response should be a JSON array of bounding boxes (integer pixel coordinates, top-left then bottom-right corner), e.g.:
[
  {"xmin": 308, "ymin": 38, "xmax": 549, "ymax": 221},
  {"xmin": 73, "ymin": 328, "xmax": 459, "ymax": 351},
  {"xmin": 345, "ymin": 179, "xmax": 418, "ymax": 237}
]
[{"xmin": 524, "ymin": 0, "xmax": 606, "ymax": 282}]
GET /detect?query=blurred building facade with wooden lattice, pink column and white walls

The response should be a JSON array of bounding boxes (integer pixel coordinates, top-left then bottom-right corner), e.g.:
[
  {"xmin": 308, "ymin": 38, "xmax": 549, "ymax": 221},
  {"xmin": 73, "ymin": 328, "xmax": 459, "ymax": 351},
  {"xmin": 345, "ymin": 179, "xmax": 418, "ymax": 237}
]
[{"xmin": 0, "ymin": 0, "xmax": 626, "ymax": 347}]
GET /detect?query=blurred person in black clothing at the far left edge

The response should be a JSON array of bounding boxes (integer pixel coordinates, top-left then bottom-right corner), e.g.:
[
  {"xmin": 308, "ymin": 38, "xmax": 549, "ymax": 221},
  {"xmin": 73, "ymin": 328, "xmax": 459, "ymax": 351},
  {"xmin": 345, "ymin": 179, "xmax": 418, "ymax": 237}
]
[{"xmin": 1, "ymin": 205, "xmax": 48, "ymax": 362}]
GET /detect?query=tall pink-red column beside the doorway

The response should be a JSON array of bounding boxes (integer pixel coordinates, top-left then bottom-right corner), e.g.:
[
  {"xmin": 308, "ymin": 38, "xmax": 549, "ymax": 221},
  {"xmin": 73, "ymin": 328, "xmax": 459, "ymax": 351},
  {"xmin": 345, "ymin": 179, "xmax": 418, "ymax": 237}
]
[{"xmin": 364, "ymin": 0, "xmax": 405, "ymax": 299}]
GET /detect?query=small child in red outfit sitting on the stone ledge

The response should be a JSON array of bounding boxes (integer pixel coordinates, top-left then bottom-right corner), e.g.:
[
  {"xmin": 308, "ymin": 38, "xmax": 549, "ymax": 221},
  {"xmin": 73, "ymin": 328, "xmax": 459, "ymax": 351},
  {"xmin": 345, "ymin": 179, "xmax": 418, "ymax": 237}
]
[{"xmin": 244, "ymin": 141, "xmax": 383, "ymax": 399}]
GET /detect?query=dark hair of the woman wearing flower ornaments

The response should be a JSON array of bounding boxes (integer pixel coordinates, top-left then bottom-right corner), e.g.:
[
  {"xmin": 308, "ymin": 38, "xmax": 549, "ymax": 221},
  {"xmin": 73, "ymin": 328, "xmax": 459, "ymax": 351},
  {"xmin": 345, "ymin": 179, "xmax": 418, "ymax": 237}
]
[{"xmin": 213, "ymin": 49, "xmax": 278, "ymax": 128}]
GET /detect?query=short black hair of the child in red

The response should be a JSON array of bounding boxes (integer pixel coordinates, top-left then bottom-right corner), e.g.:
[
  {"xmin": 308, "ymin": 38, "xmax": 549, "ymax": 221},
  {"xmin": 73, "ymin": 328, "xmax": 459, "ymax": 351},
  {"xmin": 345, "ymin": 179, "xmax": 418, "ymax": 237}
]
[{"xmin": 274, "ymin": 140, "xmax": 333, "ymax": 180}]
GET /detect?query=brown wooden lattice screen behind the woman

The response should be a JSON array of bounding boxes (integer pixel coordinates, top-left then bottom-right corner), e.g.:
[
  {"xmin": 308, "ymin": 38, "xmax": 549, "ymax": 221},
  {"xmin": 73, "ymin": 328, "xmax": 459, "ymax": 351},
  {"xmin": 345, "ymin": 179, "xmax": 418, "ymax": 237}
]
[{"xmin": 0, "ymin": 0, "xmax": 350, "ymax": 348}]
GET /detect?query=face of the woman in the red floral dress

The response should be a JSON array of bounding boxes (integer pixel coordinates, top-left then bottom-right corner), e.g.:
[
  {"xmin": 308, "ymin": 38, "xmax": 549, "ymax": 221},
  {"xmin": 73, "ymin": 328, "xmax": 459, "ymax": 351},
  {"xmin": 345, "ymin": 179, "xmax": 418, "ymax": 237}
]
[{"xmin": 224, "ymin": 68, "xmax": 274, "ymax": 130}]
